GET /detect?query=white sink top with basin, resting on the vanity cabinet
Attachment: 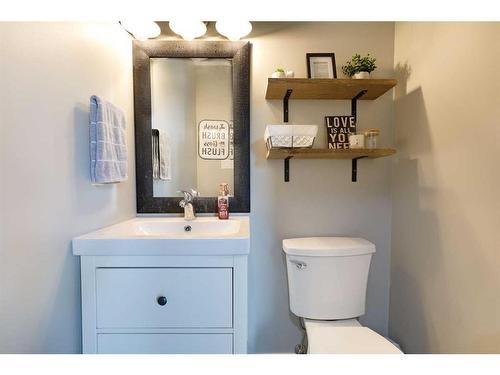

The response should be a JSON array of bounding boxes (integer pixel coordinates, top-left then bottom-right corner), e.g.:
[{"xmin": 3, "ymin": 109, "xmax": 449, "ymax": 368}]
[{"xmin": 73, "ymin": 216, "xmax": 250, "ymax": 255}]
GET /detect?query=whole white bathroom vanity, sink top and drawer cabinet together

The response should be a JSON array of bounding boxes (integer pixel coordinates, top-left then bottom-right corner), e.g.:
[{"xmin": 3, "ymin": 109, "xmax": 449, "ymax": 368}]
[{"xmin": 73, "ymin": 216, "xmax": 249, "ymax": 354}]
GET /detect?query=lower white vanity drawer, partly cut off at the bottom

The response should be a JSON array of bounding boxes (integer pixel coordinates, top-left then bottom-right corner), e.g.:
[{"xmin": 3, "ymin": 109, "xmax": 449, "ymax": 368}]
[{"xmin": 97, "ymin": 333, "xmax": 233, "ymax": 354}]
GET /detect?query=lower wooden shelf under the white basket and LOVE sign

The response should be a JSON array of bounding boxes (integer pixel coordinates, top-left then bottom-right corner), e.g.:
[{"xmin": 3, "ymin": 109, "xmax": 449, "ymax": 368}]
[{"xmin": 267, "ymin": 148, "xmax": 396, "ymax": 159}]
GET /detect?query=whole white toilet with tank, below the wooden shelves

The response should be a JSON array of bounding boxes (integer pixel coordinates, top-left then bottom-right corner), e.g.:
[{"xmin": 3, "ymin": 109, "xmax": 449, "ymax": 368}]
[{"xmin": 283, "ymin": 237, "xmax": 402, "ymax": 354}]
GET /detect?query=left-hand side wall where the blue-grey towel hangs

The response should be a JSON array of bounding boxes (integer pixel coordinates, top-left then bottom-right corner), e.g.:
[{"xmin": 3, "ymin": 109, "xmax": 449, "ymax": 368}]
[{"xmin": 0, "ymin": 23, "xmax": 135, "ymax": 353}]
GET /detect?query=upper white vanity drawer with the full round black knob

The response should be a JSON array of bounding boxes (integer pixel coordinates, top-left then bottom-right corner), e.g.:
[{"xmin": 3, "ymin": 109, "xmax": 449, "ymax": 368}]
[{"xmin": 96, "ymin": 268, "xmax": 233, "ymax": 328}]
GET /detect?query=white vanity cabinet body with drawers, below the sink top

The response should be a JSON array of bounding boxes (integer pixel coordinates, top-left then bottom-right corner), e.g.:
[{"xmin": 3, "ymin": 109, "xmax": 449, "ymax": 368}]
[{"xmin": 81, "ymin": 255, "xmax": 247, "ymax": 354}]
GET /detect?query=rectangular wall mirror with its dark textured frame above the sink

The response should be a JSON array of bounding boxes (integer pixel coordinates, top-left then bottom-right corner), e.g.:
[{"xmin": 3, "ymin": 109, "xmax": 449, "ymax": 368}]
[{"xmin": 133, "ymin": 40, "xmax": 250, "ymax": 213}]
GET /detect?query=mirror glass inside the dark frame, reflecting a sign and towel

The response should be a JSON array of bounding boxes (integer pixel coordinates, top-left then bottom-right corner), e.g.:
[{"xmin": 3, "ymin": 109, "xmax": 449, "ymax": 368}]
[{"xmin": 150, "ymin": 58, "xmax": 234, "ymax": 197}]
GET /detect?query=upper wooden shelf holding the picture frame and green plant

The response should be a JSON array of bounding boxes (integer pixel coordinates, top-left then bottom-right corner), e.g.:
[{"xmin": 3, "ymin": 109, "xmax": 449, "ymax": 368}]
[{"xmin": 266, "ymin": 78, "xmax": 398, "ymax": 100}]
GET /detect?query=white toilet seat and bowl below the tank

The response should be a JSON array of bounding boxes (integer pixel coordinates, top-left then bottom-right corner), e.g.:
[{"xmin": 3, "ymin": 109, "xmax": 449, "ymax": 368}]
[{"xmin": 304, "ymin": 319, "xmax": 402, "ymax": 354}]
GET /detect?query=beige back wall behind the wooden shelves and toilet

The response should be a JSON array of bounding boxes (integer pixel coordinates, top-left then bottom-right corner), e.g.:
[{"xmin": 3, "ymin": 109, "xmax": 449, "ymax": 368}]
[{"xmin": 249, "ymin": 22, "xmax": 394, "ymax": 352}]
